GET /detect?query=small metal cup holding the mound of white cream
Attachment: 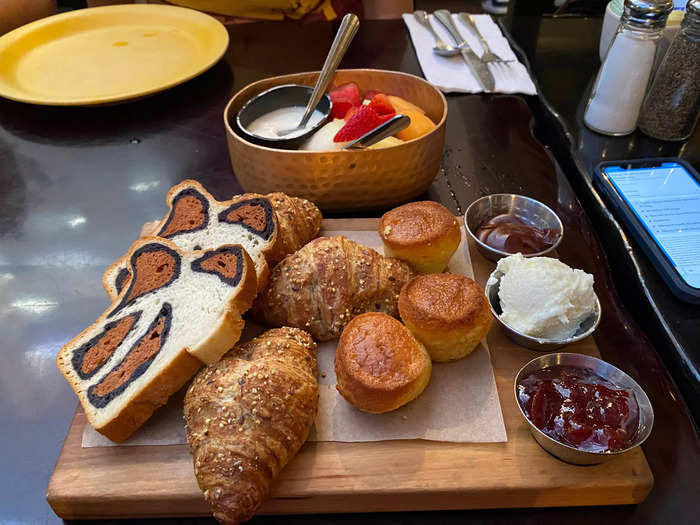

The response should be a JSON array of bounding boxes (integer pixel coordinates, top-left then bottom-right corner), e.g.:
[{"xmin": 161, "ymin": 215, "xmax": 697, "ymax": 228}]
[{"xmin": 484, "ymin": 270, "xmax": 601, "ymax": 352}]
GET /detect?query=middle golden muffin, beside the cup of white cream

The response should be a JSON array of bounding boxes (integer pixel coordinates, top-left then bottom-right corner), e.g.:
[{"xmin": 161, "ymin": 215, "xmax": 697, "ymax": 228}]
[{"xmin": 399, "ymin": 273, "xmax": 493, "ymax": 361}]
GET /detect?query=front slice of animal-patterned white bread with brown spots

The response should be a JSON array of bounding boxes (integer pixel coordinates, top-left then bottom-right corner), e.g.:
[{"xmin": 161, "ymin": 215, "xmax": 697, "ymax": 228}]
[{"xmin": 56, "ymin": 237, "xmax": 257, "ymax": 442}]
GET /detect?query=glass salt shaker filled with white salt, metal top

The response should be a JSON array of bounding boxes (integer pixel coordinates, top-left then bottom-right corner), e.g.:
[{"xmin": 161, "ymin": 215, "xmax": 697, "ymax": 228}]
[{"xmin": 583, "ymin": 0, "xmax": 673, "ymax": 135}]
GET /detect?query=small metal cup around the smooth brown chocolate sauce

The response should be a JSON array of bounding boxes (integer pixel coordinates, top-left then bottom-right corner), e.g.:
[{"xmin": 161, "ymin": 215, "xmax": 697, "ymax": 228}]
[{"xmin": 464, "ymin": 193, "xmax": 564, "ymax": 261}]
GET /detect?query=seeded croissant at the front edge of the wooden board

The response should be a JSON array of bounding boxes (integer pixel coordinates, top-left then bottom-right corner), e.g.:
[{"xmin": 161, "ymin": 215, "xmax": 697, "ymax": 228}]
[{"xmin": 185, "ymin": 328, "xmax": 318, "ymax": 524}]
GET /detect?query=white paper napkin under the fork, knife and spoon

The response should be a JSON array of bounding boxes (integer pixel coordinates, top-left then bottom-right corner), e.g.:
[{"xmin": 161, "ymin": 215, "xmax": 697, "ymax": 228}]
[{"xmin": 403, "ymin": 13, "xmax": 537, "ymax": 95}]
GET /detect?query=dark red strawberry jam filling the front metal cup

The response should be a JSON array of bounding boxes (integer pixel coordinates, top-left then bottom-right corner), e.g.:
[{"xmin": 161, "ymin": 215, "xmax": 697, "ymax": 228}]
[{"xmin": 518, "ymin": 365, "xmax": 639, "ymax": 452}]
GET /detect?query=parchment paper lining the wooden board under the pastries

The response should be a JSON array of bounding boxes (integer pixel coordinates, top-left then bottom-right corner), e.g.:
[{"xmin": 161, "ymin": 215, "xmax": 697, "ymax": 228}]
[{"xmin": 82, "ymin": 226, "xmax": 507, "ymax": 447}]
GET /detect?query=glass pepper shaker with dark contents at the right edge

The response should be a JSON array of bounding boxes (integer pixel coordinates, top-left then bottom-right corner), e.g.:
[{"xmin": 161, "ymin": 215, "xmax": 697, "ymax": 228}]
[{"xmin": 639, "ymin": 0, "xmax": 700, "ymax": 140}]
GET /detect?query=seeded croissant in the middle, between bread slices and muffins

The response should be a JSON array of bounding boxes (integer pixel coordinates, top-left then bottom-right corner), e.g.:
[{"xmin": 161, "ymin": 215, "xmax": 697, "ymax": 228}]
[{"xmin": 255, "ymin": 236, "xmax": 413, "ymax": 341}]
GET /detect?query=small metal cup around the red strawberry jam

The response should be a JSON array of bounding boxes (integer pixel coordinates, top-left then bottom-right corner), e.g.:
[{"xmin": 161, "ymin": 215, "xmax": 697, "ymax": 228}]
[{"xmin": 513, "ymin": 352, "xmax": 654, "ymax": 465}]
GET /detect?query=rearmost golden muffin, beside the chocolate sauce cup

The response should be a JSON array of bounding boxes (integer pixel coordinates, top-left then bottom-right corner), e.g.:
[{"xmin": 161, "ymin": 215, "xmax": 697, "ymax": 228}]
[{"xmin": 378, "ymin": 201, "xmax": 462, "ymax": 273}]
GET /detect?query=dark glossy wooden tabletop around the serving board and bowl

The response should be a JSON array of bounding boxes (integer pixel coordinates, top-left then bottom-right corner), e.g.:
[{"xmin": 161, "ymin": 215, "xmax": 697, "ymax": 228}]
[{"xmin": 0, "ymin": 9, "xmax": 700, "ymax": 524}]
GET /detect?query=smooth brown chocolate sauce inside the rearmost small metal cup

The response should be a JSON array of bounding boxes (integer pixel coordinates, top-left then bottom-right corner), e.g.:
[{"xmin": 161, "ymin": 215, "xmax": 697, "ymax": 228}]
[{"xmin": 476, "ymin": 214, "xmax": 559, "ymax": 254}]
